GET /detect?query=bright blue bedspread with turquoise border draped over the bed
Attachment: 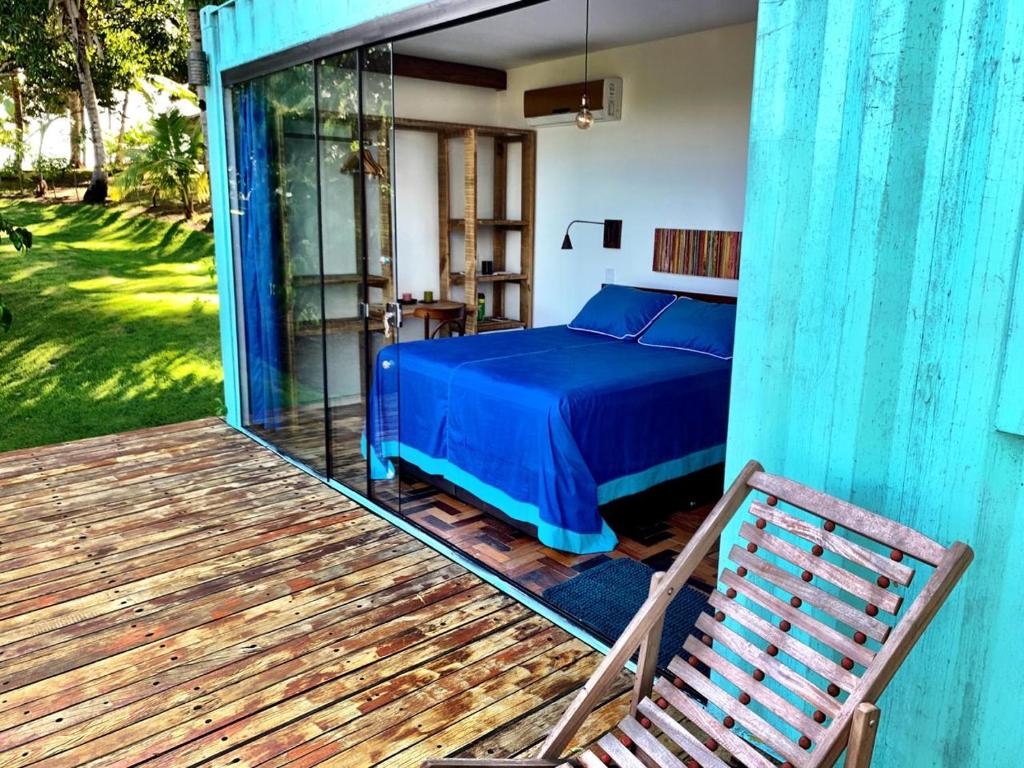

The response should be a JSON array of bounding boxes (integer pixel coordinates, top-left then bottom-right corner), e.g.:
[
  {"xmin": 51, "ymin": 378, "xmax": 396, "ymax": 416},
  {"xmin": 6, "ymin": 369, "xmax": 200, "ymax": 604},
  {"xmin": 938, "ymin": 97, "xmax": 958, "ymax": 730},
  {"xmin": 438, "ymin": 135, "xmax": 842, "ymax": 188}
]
[{"xmin": 367, "ymin": 326, "xmax": 731, "ymax": 553}]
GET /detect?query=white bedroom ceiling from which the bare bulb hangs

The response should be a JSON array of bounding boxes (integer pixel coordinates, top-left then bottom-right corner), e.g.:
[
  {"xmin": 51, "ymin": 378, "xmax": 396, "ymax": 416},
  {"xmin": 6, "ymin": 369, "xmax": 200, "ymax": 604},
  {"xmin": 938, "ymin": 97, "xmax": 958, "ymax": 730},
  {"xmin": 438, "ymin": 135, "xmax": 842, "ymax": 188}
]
[{"xmin": 394, "ymin": 0, "xmax": 757, "ymax": 70}]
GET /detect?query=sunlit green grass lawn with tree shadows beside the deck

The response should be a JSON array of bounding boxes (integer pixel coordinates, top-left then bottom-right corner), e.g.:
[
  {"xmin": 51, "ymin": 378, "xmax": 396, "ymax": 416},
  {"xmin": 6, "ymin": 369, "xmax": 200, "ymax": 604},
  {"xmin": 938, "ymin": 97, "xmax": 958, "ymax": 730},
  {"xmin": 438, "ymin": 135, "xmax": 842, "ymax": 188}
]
[{"xmin": 0, "ymin": 202, "xmax": 222, "ymax": 451}]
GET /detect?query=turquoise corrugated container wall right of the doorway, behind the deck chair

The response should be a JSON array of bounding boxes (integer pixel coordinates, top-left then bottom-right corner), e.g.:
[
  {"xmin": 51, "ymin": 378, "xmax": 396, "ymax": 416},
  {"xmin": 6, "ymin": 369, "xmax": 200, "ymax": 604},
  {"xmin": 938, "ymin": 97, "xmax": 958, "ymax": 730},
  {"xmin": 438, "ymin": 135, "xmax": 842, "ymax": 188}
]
[{"xmin": 726, "ymin": 0, "xmax": 1024, "ymax": 768}]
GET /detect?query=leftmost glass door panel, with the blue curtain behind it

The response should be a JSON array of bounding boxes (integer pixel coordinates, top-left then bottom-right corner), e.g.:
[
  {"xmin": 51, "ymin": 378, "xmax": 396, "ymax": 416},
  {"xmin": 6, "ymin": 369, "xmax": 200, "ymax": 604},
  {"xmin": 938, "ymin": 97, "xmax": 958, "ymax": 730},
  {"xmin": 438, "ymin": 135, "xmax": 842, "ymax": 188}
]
[{"xmin": 231, "ymin": 65, "xmax": 327, "ymax": 472}]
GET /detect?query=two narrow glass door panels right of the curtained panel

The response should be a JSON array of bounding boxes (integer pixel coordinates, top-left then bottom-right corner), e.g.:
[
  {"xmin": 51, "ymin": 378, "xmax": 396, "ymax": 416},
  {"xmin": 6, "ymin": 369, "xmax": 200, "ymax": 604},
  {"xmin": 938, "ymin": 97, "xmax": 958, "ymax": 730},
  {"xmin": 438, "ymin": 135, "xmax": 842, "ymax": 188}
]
[{"xmin": 317, "ymin": 46, "xmax": 399, "ymax": 508}]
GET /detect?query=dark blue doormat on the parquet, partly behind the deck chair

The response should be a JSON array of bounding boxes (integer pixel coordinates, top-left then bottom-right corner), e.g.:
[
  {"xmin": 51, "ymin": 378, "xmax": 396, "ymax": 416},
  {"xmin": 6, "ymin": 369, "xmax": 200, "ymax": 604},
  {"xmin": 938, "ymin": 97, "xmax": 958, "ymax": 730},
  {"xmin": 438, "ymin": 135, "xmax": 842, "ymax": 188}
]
[{"xmin": 544, "ymin": 557, "xmax": 713, "ymax": 669}]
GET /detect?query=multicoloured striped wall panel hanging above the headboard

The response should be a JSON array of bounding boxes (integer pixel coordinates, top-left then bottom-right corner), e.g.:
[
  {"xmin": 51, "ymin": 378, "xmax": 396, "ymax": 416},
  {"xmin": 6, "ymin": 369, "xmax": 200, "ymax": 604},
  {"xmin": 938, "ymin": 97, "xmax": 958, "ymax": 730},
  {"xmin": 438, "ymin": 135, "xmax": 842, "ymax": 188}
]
[{"xmin": 653, "ymin": 229, "xmax": 742, "ymax": 280}]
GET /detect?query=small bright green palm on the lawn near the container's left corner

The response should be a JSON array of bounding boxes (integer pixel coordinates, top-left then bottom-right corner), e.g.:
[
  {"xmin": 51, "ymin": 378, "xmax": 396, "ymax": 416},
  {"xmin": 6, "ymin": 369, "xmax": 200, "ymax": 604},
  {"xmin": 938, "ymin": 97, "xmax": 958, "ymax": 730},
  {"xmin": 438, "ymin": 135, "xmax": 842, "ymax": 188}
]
[{"xmin": 115, "ymin": 109, "xmax": 209, "ymax": 219}]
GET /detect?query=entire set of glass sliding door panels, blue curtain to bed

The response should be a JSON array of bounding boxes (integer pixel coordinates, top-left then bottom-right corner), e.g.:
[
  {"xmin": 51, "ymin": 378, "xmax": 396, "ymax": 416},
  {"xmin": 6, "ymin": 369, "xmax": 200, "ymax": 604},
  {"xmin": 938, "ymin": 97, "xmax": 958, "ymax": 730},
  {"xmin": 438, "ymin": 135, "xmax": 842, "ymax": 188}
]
[{"xmin": 230, "ymin": 45, "xmax": 400, "ymax": 508}]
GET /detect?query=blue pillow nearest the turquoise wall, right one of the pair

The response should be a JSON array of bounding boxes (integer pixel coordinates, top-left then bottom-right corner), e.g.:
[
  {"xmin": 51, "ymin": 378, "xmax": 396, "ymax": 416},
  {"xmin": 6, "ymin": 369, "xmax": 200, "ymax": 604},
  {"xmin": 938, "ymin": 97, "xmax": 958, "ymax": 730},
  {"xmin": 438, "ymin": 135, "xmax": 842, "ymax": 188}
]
[{"xmin": 640, "ymin": 299, "xmax": 736, "ymax": 360}]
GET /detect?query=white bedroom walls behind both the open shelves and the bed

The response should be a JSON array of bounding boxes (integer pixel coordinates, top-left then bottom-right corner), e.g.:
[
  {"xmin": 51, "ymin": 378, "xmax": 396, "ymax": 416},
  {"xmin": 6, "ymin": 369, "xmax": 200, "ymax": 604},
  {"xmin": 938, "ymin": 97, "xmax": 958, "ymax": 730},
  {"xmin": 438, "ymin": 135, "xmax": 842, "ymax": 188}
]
[{"xmin": 387, "ymin": 24, "xmax": 755, "ymax": 331}]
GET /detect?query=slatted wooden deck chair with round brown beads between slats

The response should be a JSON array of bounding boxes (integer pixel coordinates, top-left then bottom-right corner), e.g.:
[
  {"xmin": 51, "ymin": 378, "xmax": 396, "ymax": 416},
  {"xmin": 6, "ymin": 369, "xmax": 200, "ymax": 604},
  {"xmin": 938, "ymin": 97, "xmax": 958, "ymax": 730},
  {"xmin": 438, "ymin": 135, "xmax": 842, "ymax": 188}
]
[{"xmin": 425, "ymin": 462, "xmax": 974, "ymax": 768}]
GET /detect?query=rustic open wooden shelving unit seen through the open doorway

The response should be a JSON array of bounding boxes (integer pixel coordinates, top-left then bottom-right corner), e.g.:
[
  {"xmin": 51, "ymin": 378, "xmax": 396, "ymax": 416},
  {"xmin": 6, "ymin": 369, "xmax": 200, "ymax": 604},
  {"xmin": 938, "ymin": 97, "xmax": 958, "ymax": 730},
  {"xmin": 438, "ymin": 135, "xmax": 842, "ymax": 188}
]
[{"xmin": 395, "ymin": 118, "xmax": 537, "ymax": 334}]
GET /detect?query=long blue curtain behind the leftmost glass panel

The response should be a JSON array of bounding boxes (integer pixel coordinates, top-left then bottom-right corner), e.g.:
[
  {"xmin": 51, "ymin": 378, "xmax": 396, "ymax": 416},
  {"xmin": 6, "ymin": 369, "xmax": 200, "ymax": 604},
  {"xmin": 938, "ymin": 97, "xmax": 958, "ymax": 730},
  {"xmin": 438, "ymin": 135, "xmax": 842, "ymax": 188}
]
[{"xmin": 237, "ymin": 83, "xmax": 287, "ymax": 429}]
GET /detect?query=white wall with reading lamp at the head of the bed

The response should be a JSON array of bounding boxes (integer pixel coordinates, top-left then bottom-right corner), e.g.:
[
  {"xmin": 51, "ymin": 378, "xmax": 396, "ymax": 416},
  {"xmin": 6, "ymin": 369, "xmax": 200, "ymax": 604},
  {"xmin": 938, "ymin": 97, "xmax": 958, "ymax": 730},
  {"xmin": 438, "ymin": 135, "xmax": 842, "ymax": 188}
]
[{"xmin": 499, "ymin": 24, "xmax": 755, "ymax": 326}]
